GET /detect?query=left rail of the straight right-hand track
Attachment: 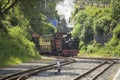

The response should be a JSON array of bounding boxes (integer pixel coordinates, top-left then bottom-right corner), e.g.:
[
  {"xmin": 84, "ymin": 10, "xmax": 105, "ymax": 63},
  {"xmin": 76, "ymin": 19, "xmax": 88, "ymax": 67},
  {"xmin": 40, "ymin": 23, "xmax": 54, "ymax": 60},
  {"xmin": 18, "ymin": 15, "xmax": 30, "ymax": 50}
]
[{"xmin": 73, "ymin": 61, "xmax": 108, "ymax": 80}]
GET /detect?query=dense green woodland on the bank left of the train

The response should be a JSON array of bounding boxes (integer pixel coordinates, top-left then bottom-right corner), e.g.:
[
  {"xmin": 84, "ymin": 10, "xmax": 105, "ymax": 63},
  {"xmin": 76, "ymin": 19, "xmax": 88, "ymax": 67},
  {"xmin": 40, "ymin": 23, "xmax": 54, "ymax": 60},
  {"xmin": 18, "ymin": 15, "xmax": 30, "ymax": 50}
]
[{"xmin": 0, "ymin": 0, "xmax": 62, "ymax": 66}]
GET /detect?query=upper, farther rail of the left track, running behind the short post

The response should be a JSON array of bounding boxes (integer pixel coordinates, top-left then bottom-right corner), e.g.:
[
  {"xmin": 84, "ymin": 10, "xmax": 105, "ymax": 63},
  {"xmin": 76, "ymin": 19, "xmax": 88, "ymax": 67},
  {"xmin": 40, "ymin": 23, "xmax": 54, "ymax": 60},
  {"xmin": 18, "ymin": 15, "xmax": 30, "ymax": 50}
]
[{"xmin": 0, "ymin": 60, "xmax": 70, "ymax": 80}]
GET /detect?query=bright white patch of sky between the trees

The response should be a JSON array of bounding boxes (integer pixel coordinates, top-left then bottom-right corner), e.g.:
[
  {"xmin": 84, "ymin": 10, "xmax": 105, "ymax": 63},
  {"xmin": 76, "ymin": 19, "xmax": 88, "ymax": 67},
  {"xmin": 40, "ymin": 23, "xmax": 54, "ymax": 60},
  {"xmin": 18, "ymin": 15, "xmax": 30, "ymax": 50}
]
[{"xmin": 56, "ymin": 0, "xmax": 74, "ymax": 27}]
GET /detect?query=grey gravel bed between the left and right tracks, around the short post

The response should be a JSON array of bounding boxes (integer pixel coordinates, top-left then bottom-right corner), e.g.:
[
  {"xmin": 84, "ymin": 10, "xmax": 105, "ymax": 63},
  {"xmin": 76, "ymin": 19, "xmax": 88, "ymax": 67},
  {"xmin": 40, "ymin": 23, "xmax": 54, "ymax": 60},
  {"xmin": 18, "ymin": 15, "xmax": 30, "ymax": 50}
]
[{"xmin": 27, "ymin": 59, "xmax": 102, "ymax": 80}]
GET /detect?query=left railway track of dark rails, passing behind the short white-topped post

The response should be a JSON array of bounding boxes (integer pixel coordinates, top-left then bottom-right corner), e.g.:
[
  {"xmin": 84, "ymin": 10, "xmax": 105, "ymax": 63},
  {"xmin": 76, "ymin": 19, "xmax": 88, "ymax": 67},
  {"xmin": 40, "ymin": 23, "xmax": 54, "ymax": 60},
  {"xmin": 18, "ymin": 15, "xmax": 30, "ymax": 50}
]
[{"xmin": 0, "ymin": 59, "xmax": 75, "ymax": 80}]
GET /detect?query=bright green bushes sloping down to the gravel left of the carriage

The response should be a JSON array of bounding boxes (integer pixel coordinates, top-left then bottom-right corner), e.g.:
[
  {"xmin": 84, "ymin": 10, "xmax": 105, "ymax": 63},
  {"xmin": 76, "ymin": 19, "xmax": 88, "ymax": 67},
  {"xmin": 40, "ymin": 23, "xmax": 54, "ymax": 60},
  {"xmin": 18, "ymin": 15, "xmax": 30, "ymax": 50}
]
[{"xmin": 0, "ymin": 27, "xmax": 39, "ymax": 66}]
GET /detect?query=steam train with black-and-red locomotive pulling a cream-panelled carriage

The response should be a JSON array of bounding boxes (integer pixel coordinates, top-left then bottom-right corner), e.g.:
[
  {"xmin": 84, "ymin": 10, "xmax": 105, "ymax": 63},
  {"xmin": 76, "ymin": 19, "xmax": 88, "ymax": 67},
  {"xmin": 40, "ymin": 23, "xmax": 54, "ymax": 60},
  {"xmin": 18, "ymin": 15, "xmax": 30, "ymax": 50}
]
[{"xmin": 32, "ymin": 33, "xmax": 79, "ymax": 56}]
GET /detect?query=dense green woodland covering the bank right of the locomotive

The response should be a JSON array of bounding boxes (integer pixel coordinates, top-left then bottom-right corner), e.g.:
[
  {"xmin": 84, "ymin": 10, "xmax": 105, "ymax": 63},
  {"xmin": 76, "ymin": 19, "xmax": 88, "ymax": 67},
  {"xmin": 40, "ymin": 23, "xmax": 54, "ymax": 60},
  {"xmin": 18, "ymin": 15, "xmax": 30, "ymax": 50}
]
[{"xmin": 71, "ymin": 0, "xmax": 120, "ymax": 57}]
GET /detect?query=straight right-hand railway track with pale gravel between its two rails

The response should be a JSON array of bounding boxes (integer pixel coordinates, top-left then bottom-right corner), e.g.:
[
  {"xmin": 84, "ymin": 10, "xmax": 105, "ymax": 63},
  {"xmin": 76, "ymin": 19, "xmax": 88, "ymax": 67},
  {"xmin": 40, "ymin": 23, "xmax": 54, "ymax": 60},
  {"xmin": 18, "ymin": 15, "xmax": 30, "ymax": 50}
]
[{"xmin": 73, "ymin": 61, "xmax": 115, "ymax": 80}]
